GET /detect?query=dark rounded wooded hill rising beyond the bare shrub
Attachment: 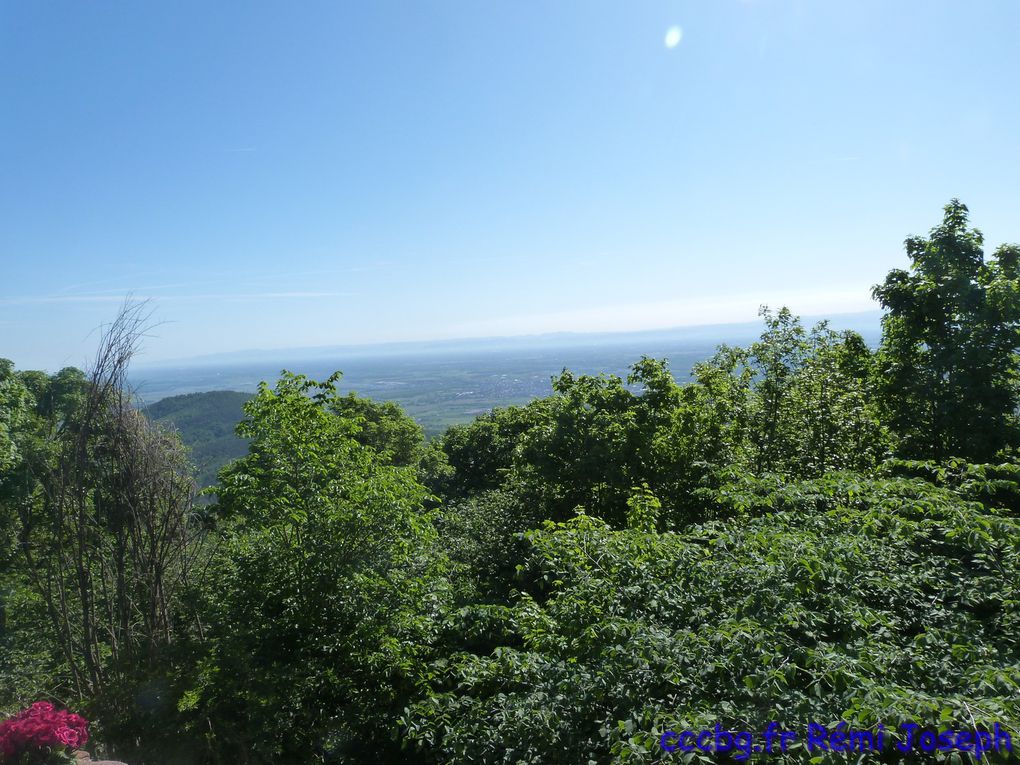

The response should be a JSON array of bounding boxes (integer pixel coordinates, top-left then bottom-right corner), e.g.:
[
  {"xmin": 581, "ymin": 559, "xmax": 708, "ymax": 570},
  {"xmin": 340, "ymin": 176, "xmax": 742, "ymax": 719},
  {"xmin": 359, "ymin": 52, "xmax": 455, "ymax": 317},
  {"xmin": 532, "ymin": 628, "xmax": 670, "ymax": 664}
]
[{"xmin": 143, "ymin": 391, "xmax": 252, "ymax": 488}]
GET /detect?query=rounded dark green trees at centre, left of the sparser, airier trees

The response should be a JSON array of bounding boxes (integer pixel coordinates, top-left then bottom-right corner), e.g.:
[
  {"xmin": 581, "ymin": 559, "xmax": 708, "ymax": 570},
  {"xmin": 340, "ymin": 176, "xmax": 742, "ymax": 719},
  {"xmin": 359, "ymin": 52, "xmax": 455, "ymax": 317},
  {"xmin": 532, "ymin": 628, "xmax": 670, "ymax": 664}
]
[{"xmin": 438, "ymin": 358, "xmax": 730, "ymax": 531}]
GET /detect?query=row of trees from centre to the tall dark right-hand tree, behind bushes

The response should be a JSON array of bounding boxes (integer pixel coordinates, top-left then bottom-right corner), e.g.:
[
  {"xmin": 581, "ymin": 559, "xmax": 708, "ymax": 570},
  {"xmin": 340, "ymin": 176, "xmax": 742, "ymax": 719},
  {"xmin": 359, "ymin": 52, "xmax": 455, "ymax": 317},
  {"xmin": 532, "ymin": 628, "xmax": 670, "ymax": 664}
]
[{"xmin": 439, "ymin": 308, "xmax": 887, "ymax": 530}]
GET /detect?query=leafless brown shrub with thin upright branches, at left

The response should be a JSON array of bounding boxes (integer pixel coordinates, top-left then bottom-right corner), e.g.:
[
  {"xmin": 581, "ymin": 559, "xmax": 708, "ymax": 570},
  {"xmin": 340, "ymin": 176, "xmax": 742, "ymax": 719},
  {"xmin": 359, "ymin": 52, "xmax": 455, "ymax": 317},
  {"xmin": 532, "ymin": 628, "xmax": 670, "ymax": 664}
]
[{"xmin": 21, "ymin": 302, "xmax": 203, "ymax": 700}]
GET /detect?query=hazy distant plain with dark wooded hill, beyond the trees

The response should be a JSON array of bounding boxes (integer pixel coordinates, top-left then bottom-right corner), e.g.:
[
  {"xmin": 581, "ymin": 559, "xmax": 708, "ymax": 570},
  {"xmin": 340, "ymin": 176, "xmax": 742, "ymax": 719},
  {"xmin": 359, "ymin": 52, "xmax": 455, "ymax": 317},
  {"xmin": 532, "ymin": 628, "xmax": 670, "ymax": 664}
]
[{"xmin": 133, "ymin": 346, "xmax": 712, "ymax": 487}]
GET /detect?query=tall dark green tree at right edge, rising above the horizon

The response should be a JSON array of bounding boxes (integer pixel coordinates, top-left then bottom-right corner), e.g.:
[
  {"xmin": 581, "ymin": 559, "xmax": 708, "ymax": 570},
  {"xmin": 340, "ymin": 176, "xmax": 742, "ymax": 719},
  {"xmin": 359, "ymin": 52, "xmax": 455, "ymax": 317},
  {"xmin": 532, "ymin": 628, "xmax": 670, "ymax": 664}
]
[{"xmin": 873, "ymin": 199, "xmax": 1020, "ymax": 461}]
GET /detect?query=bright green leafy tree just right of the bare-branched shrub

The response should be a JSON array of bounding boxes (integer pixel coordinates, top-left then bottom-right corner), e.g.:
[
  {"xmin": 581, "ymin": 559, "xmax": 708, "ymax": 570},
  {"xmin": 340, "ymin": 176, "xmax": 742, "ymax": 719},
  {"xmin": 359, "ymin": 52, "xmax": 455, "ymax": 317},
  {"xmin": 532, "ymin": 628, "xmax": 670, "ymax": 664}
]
[{"xmin": 182, "ymin": 373, "xmax": 447, "ymax": 763}]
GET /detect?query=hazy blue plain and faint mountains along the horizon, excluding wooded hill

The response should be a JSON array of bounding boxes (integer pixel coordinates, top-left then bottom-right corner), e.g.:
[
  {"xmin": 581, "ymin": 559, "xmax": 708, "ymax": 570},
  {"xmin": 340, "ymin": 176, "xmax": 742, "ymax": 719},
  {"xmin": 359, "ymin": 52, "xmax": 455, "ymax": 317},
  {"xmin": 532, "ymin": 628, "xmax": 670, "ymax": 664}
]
[{"xmin": 132, "ymin": 311, "xmax": 878, "ymax": 436}]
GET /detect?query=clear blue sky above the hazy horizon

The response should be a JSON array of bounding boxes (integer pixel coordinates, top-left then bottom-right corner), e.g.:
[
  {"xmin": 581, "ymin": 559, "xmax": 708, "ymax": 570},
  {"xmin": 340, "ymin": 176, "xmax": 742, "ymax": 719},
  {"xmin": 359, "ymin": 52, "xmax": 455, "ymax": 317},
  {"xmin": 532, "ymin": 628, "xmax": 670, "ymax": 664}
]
[{"xmin": 0, "ymin": 0, "xmax": 1020, "ymax": 368}]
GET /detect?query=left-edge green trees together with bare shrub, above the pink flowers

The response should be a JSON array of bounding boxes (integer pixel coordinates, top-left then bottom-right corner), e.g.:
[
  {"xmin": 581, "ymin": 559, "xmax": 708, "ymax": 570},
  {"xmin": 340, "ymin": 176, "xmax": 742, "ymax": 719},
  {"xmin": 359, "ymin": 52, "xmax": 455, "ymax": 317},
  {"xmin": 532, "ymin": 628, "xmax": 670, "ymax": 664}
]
[{"xmin": 0, "ymin": 344, "xmax": 205, "ymax": 762}]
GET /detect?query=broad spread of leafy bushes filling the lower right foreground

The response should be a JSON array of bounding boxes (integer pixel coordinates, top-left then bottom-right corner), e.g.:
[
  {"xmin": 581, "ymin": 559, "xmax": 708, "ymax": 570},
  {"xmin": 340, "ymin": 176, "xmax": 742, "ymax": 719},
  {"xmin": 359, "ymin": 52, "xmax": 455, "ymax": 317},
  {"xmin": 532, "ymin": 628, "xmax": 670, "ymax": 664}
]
[{"xmin": 404, "ymin": 473, "xmax": 1020, "ymax": 763}]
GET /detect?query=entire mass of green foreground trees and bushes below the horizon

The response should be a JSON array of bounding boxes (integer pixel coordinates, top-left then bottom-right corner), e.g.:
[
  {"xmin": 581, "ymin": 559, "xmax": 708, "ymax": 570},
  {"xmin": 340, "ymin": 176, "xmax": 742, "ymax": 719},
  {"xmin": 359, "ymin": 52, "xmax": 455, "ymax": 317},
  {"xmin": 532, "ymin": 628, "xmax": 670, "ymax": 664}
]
[{"xmin": 0, "ymin": 200, "xmax": 1020, "ymax": 765}]
